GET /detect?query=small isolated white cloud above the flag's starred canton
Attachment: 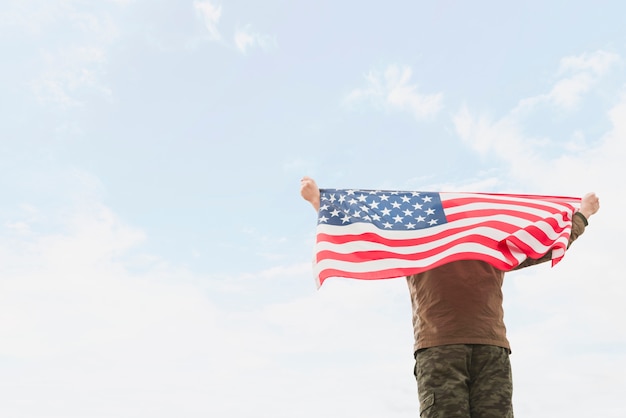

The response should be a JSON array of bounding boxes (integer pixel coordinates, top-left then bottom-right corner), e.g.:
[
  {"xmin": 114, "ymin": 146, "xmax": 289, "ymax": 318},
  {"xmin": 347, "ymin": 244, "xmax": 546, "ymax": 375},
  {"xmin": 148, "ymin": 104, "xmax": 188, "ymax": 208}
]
[{"xmin": 346, "ymin": 65, "xmax": 443, "ymax": 119}]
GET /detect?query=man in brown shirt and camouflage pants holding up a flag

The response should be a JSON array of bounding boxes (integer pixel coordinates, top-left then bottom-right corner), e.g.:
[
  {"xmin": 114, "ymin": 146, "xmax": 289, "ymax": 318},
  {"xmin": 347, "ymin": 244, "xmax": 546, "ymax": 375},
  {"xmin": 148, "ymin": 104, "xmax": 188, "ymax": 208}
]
[{"xmin": 300, "ymin": 177, "xmax": 600, "ymax": 418}]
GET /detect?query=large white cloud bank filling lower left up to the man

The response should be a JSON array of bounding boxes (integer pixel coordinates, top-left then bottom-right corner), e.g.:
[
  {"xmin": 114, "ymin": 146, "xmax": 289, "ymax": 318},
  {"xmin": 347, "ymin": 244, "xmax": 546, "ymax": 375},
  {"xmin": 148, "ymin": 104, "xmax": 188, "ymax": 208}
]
[{"xmin": 0, "ymin": 173, "xmax": 417, "ymax": 418}]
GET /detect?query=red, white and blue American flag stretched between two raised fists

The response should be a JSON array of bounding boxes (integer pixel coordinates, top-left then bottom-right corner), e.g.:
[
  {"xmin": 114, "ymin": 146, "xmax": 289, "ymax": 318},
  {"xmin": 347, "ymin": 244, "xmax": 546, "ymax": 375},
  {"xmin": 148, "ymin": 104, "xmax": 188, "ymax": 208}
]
[{"xmin": 314, "ymin": 189, "xmax": 580, "ymax": 286}]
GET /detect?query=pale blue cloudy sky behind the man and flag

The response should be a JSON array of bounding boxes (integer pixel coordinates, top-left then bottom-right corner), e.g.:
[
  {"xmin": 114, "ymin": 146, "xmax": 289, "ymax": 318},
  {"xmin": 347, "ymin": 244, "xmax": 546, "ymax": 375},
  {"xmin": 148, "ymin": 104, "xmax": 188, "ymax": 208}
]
[{"xmin": 0, "ymin": 0, "xmax": 626, "ymax": 418}]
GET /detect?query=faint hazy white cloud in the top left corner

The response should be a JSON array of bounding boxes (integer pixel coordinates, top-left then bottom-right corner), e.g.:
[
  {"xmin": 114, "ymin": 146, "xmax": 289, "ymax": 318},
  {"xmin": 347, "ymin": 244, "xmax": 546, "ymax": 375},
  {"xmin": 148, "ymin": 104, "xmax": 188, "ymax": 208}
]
[{"xmin": 0, "ymin": 0, "xmax": 122, "ymax": 107}]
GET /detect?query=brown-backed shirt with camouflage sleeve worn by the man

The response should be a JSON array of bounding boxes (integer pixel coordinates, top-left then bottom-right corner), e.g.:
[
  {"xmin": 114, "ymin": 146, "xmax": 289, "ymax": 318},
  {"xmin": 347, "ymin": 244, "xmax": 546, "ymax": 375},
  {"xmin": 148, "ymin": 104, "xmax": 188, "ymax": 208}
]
[{"xmin": 407, "ymin": 213, "xmax": 587, "ymax": 351}]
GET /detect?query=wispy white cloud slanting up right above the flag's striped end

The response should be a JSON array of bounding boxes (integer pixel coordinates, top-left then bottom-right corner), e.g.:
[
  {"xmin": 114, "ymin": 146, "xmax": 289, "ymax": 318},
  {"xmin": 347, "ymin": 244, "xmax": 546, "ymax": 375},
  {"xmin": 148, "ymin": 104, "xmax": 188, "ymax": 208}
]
[{"xmin": 453, "ymin": 51, "xmax": 620, "ymax": 185}]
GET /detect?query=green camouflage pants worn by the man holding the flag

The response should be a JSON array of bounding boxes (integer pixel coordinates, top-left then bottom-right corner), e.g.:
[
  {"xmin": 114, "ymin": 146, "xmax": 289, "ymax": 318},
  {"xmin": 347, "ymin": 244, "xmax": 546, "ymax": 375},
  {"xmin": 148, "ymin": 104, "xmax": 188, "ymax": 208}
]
[{"xmin": 414, "ymin": 344, "xmax": 513, "ymax": 418}]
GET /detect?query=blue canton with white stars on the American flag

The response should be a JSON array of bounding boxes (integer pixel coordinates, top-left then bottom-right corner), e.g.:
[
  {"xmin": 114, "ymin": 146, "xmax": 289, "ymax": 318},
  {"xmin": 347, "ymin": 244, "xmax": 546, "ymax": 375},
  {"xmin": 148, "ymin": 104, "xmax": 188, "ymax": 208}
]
[{"xmin": 318, "ymin": 189, "xmax": 446, "ymax": 231}]
